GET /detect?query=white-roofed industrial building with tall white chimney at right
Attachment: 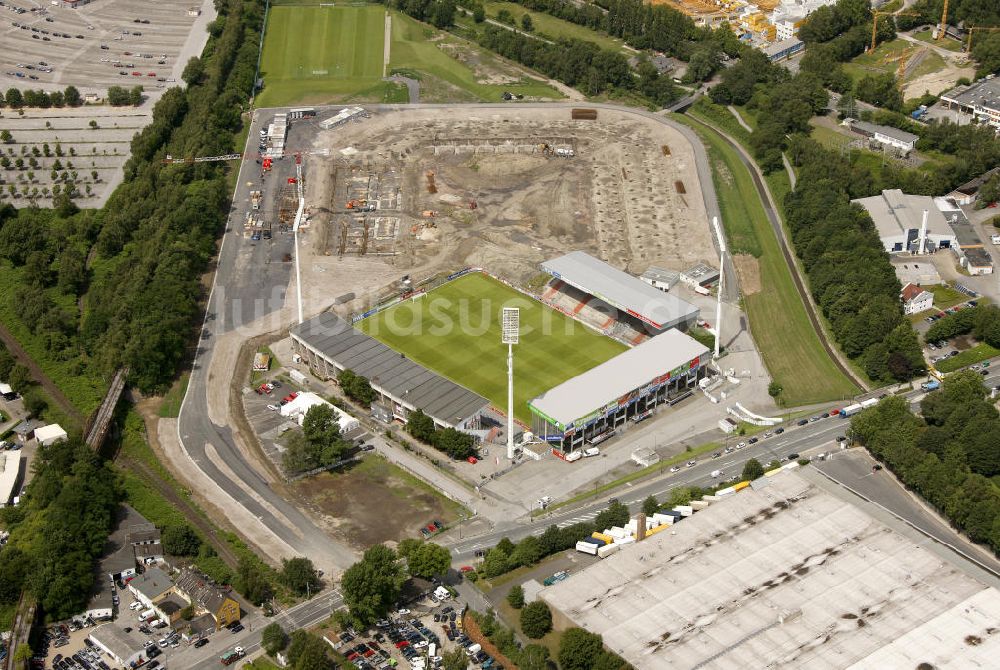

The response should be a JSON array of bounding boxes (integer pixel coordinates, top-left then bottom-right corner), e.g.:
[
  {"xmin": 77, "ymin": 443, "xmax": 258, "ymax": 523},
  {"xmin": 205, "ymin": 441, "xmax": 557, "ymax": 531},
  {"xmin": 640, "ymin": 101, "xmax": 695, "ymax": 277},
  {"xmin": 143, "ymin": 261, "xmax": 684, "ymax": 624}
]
[{"xmin": 851, "ymin": 189, "xmax": 956, "ymax": 254}]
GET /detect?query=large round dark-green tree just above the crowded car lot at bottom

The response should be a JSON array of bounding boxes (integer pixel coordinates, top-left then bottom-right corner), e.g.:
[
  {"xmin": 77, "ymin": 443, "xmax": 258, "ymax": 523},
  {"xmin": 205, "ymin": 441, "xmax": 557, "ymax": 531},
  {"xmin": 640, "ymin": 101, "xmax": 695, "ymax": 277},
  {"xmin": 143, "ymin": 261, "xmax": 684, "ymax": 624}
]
[{"xmin": 341, "ymin": 545, "xmax": 406, "ymax": 625}]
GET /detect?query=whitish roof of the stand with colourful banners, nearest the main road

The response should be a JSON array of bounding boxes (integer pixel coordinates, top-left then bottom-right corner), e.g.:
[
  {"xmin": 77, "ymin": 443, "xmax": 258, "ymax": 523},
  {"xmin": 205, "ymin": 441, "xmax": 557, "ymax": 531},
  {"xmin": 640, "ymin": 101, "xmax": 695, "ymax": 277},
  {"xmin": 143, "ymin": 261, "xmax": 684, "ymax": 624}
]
[{"xmin": 530, "ymin": 330, "xmax": 709, "ymax": 426}]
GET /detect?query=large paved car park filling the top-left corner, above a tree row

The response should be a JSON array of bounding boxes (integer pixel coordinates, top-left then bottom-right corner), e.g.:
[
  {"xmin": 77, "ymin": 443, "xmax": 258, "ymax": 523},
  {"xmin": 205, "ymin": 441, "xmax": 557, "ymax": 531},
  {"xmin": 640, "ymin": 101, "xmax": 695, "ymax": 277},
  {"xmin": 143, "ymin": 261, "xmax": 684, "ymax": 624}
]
[{"xmin": 0, "ymin": 0, "xmax": 214, "ymax": 95}]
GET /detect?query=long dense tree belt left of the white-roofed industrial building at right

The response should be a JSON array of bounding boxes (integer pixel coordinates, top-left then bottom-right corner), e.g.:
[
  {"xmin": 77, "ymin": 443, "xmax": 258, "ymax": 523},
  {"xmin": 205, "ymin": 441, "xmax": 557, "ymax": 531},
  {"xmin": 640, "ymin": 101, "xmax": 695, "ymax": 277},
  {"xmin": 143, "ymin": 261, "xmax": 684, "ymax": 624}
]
[{"xmin": 784, "ymin": 139, "xmax": 925, "ymax": 383}]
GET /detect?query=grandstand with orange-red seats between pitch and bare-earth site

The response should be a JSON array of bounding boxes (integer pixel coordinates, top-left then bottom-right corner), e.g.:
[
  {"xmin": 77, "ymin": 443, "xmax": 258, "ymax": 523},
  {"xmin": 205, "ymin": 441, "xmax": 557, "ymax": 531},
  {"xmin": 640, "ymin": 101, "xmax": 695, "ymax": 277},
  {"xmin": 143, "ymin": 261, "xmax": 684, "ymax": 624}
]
[{"xmin": 541, "ymin": 251, "xmax": 698, "ymax": 346}]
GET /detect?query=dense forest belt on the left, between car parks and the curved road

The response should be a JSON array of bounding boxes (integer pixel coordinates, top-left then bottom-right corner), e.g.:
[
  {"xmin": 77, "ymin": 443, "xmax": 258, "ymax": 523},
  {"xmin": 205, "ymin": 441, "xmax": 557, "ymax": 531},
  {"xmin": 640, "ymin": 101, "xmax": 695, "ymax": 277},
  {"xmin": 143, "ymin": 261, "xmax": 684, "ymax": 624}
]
[{"xmin": 0, "ymin": 0, "xmax": 263, "ymax": 392}]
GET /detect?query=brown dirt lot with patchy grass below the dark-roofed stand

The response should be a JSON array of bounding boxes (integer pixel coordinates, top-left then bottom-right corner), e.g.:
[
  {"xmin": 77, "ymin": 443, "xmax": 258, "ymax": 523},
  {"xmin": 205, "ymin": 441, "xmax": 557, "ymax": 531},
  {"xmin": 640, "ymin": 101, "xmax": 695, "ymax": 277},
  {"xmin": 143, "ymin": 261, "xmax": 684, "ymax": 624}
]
[{"xmin": 290, "ymin": 454, "xmax": 459, "ymax": 549}]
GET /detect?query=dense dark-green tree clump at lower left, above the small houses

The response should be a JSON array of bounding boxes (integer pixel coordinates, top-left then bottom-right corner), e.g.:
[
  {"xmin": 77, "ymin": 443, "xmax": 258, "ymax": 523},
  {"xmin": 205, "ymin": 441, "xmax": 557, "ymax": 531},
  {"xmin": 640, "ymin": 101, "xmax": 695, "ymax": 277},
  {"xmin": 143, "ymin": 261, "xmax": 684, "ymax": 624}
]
[{"xmin": 0, "ymin": 436, "xmax": 122, "ymax": 620}]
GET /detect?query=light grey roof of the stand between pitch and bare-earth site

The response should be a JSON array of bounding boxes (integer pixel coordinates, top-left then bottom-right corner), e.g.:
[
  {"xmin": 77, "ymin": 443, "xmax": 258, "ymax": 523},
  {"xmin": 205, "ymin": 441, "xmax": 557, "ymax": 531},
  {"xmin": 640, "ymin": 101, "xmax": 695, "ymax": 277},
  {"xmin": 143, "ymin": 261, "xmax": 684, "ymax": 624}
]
[{"xmin": 542, "ymin": 251, "xmax": 698, "ymax": 329}]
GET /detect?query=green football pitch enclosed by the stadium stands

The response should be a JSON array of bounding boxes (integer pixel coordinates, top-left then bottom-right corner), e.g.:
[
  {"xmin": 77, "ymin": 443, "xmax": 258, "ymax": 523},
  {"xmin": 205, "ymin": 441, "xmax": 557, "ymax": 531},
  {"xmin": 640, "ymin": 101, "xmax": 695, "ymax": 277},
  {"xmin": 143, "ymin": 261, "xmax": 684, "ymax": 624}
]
[{"xmin": 357, "ymin": 273, "xmax": 627, "ymax": 425}]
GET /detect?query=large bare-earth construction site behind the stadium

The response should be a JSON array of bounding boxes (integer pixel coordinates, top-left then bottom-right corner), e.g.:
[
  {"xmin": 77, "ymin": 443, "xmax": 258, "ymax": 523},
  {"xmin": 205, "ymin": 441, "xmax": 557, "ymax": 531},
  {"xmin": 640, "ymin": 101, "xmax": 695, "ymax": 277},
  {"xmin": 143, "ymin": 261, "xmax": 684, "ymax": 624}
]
[{"xmin": 288, "ymin": 107, "xmax": 716, "ymax": 312}]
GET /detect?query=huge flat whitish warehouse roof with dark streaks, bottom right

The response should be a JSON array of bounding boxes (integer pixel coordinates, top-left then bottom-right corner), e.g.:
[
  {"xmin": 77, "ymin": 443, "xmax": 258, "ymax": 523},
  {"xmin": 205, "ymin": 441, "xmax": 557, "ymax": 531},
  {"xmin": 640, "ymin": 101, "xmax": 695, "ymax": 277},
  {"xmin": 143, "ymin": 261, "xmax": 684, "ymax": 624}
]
[{"xmin": 539, "ymin": 472, "xmax": 1000, "ymax": 670}]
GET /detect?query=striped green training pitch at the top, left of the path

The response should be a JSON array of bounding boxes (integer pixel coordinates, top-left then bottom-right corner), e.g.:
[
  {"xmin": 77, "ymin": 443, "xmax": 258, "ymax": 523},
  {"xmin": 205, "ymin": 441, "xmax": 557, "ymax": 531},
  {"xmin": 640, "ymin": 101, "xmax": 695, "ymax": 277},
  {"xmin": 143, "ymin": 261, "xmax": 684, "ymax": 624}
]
[{"xmin": 258, "ymin": 5, "xmax": 386, "ymax": 107}]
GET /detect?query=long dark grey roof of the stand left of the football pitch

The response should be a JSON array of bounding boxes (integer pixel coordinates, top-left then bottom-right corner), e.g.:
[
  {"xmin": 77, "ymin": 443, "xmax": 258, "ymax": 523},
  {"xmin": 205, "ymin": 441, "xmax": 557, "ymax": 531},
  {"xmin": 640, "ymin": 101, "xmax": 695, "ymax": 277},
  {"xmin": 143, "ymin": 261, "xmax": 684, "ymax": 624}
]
[{"xmin": 291, "ymin": 312, "xmax": 490, "ymax": 425}]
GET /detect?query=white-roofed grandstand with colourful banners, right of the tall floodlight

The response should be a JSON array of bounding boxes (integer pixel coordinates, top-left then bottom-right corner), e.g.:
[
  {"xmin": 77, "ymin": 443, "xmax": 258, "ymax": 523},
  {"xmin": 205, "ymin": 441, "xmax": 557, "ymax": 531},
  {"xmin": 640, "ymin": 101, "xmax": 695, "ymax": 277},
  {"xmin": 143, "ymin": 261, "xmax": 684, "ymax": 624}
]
[{"xmin": 528, "ymin": 328, "xmax": 711, "ymax": 456}]
